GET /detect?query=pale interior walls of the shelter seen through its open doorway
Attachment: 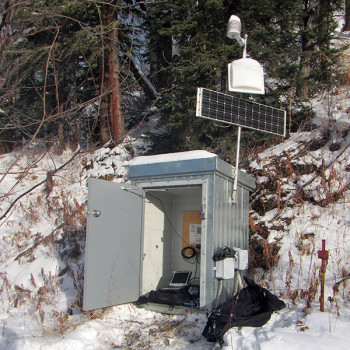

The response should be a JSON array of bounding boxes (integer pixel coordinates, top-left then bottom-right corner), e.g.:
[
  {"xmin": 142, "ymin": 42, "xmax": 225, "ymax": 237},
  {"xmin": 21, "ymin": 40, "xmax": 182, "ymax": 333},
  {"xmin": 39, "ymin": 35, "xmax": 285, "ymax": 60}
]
[{"xmin": 141, "ymin": 186, "xmax": 201, "ymax": 294}]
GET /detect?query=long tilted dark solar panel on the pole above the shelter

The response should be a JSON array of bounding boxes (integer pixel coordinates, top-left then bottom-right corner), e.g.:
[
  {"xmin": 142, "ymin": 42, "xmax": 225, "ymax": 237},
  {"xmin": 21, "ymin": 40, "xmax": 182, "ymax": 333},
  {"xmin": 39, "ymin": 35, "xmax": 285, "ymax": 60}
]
[{"xmin": 196, "ymin": 88, "xmax": 286, "ymax": 136}]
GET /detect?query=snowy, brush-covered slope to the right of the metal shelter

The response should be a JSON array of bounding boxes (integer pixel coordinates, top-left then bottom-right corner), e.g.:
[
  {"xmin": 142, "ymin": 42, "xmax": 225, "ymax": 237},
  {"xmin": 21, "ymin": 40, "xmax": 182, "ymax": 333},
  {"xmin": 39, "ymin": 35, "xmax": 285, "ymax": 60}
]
[{"xmin": 247, "ymin": 91, "xmax": 350, "ymax": 299}]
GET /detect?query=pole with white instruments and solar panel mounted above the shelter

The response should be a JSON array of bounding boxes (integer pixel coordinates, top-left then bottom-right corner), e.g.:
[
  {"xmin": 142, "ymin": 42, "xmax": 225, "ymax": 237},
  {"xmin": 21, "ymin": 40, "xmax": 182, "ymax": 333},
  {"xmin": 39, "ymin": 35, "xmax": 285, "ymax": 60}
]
[{"xmin": 196, "ymin": 15, "xmax": 286, "ymax": 203}]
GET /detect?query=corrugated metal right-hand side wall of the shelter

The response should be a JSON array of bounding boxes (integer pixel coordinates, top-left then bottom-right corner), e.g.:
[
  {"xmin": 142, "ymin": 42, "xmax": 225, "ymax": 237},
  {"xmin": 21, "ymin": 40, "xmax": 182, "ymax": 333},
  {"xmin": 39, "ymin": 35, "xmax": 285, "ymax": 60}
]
[{"xmin": 197, "ymin": 165, "xmax": 249, "ymax": 310}]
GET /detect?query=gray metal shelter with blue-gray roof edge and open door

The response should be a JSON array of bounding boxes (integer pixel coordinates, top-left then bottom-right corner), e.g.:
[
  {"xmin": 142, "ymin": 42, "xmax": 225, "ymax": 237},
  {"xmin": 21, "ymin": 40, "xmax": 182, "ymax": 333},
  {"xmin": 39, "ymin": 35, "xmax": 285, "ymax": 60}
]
[{"xmin": 83, "ymin": 151, "xmax": 255, "ymax": 311}]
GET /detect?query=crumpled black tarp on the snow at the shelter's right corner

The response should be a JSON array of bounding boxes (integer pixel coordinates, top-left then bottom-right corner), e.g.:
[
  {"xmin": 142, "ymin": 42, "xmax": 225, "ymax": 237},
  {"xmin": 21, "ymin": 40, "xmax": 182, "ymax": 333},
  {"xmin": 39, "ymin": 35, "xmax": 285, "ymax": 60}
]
[{"xmin": 202, "ymin": 277, "xmax": 286, "ymax": 342}]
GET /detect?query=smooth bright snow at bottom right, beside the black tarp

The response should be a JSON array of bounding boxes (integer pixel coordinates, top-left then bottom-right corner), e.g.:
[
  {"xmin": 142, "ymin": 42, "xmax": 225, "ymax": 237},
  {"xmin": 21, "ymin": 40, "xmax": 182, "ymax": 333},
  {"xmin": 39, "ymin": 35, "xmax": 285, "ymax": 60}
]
[{"xmin": 222, "ymin": 305, "xmax": 350, "ymax": 350}]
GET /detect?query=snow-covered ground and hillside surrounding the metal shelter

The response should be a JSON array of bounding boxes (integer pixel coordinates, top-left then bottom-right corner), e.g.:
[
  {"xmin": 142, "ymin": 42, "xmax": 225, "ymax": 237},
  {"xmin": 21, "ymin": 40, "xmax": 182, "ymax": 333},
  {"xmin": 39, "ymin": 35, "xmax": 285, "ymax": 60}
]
[{"xmin": 0, "ymin": 87, "xmax": 350, "ymax": 350}]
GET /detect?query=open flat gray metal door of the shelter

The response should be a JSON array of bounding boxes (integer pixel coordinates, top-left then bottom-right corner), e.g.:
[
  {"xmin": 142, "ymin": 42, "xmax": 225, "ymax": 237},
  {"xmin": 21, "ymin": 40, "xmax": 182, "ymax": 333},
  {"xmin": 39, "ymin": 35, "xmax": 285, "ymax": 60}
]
[{"xmin": 83, "ymin": 179, "xmax": 144, "ymax": 310}]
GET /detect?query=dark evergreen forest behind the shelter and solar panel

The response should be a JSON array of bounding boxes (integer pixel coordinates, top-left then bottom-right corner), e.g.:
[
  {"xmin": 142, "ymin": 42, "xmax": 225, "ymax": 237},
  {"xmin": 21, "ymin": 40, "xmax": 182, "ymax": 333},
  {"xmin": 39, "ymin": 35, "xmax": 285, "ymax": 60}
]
[{"xmin": 0, "ymin": 0, "xmax": 350, "ymax": 162}]
